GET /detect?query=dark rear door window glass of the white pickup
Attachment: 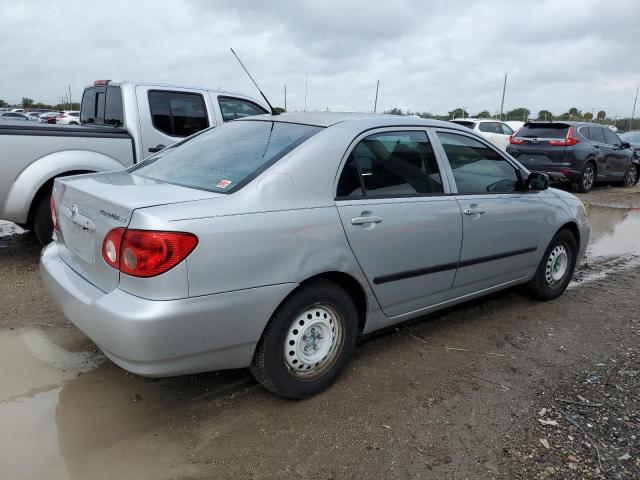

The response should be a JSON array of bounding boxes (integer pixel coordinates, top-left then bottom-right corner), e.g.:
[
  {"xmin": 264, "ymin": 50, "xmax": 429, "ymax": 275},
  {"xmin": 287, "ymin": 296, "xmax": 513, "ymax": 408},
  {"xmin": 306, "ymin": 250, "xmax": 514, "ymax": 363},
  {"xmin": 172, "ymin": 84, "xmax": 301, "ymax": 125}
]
[{"xmin": 148, "ymin": 90, "xmax": 209, "ymax": 137}]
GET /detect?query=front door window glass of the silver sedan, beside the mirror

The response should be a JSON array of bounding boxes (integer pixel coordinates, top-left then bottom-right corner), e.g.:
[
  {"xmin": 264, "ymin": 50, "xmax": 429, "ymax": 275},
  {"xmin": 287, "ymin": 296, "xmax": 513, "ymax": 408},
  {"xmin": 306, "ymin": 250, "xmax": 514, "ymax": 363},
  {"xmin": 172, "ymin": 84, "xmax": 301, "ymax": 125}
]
[{"xmin": 438, "ymin": 132, "xmax": 518, "ymax": 194}]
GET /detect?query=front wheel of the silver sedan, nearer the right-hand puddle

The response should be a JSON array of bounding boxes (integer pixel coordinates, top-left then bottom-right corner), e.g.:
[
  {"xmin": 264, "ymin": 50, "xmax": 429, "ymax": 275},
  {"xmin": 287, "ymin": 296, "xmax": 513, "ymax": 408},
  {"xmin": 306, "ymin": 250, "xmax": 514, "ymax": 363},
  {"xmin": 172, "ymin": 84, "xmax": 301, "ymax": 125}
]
[{"xmin": 528, "ymin": 228, "xmax": 578, "ymax": 300}]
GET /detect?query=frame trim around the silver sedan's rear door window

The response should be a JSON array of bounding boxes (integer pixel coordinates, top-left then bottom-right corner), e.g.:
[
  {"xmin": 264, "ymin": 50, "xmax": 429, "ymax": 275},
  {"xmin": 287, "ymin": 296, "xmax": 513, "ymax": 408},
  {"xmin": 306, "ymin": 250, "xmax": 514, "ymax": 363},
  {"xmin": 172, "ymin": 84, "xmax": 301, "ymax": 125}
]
[{"xmin": 333, "ymin": 125, "xmax": 456, "ymax": 202}]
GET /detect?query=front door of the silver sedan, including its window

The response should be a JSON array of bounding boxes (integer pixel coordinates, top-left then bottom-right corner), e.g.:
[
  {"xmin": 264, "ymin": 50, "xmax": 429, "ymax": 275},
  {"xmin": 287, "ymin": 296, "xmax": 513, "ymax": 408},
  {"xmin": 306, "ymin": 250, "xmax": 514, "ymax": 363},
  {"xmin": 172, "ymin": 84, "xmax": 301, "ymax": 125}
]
[{"xmin": 437, "ymin": 129, "xmax": 553, "ymax": 298}]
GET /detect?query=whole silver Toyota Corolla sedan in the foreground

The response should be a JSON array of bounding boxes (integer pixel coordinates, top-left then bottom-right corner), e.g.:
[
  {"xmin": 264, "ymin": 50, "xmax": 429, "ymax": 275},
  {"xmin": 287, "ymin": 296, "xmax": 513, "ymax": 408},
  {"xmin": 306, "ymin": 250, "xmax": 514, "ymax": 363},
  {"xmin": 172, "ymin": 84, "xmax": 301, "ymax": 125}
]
[{"xmin": 41, "ymin": 113, "xmax": 589, "ymax": 398}]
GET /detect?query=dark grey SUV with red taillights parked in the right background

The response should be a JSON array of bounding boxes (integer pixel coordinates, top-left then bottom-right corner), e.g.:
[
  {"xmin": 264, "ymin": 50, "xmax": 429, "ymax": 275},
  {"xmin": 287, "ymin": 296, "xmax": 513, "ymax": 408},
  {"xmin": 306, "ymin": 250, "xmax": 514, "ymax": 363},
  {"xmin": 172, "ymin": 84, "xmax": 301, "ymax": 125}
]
[{"xmin": 507, "ymin": 122, "xmax": 640, "ymax": 192}]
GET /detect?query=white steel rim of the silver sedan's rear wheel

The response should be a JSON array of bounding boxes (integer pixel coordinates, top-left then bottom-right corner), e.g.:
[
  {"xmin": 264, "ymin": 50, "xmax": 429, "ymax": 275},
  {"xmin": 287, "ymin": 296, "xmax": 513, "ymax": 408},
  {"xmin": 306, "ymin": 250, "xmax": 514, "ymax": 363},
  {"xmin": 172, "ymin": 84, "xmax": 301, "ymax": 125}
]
[{"xmin": 284, "ymin": 303, "xmax": 343, "ymax": 380}]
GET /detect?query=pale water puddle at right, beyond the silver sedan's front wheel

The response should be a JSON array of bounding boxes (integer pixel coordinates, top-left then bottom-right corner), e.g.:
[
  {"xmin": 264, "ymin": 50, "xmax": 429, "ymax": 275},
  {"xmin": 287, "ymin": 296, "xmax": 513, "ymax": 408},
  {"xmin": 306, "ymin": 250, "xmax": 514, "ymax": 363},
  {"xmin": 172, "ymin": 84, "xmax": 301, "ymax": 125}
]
[{"xmin": 569, "ymin": 206, "xmax": 640, "ymax": 288}]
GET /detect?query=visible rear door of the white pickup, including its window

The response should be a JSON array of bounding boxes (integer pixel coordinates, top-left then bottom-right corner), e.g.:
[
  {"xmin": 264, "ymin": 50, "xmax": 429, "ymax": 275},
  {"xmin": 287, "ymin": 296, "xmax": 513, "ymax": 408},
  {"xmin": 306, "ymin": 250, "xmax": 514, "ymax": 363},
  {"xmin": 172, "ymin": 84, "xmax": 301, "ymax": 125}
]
[{"xmin": 136, "ymin": 85, "xmax": 216, "ymax": 158}]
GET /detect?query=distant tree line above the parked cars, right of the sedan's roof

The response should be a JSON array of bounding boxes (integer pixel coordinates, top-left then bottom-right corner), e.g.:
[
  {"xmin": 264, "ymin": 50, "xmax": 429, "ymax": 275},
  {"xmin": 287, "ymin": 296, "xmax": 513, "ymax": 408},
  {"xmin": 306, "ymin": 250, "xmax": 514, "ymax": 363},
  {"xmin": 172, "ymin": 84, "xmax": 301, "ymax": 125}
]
[{"xmin": 384, "ymin": 107, "xmax": 640, "ymax": 130}]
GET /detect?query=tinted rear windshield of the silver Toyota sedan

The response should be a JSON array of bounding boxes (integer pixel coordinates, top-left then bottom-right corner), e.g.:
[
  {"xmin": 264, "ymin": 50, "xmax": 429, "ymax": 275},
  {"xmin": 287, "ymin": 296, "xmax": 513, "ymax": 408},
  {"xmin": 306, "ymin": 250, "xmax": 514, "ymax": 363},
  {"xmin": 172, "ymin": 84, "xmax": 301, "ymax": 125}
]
[{"xmin": 129, "ymin": 120, "xmax": 322, "ymax": 193}]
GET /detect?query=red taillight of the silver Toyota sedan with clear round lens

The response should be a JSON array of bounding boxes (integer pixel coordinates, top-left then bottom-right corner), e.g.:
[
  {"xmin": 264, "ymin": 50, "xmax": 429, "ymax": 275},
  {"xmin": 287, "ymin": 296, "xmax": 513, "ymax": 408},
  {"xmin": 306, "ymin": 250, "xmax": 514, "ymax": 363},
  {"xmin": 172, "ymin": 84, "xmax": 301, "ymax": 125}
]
[{"xmin": 102, "ymin": 228, "xmax": 198, "ymax": 277}]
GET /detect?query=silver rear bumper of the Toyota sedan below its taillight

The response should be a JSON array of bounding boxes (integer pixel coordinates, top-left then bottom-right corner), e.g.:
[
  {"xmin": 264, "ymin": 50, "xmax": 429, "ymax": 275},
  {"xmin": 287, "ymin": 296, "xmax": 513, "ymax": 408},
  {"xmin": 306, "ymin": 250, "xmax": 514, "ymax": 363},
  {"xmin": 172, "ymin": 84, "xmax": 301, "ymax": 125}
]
[{"xmin": 40, "ymin": 242, "xmax": 297, "ymax": 376}]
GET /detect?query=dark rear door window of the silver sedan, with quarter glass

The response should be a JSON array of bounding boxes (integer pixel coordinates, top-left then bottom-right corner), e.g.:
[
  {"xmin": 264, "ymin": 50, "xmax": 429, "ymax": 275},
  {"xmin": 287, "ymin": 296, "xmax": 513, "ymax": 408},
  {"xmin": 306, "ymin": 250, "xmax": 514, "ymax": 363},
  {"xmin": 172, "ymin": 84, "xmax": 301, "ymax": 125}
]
[{"xmin": 337, "ymin": 131, "xmax": 444, "ymax": 197}]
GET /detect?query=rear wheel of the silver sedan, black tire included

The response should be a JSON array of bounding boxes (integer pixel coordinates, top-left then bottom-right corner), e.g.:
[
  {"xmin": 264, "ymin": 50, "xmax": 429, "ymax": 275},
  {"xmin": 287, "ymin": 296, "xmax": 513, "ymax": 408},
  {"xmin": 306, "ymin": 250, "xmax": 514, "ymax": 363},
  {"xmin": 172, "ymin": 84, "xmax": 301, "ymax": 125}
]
[{"xmin": 251, "ymin": 280, "xmax": 358, "ymax": 399}]
